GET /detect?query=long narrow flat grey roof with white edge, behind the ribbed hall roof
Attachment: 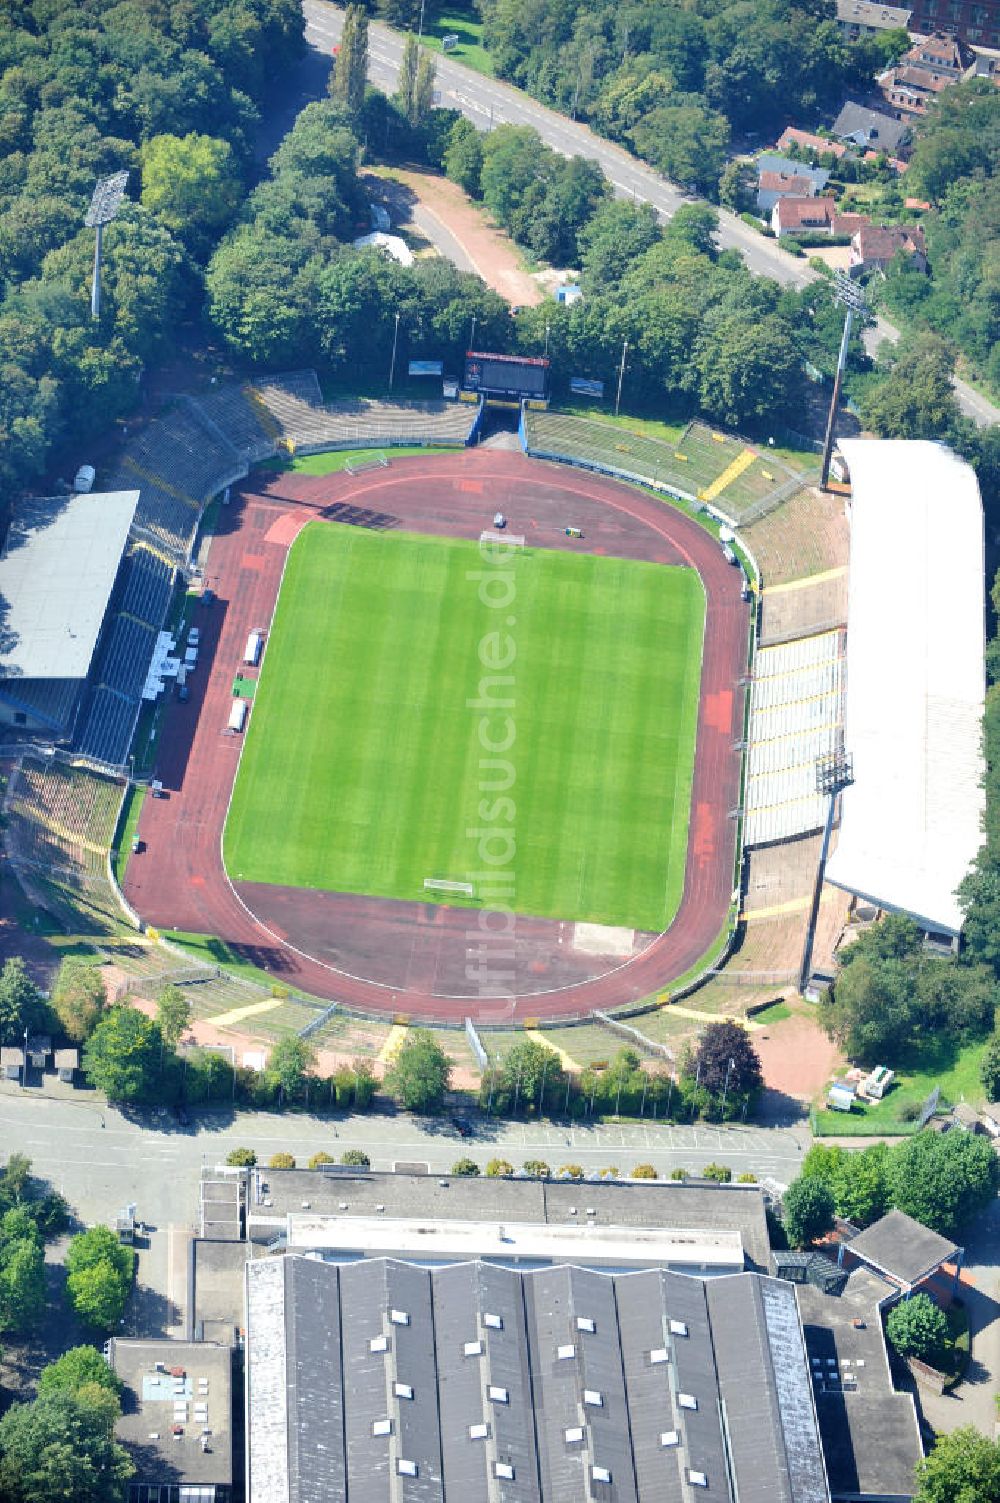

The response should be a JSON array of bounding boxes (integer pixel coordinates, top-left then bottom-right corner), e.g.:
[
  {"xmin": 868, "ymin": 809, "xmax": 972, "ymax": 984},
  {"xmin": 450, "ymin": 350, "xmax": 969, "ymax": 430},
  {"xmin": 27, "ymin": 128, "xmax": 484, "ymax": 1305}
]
[{"xmin": 247, "ymin": 1169, "xmax": 770, "ymax": 1272}]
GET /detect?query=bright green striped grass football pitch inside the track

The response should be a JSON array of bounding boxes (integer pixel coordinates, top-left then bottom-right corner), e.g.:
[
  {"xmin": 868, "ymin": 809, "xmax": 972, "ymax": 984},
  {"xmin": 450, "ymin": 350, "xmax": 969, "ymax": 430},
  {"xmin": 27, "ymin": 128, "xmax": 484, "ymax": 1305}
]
[{"xmin": 224, "ymin": 522, "xmax": 705, "ymax": 930}]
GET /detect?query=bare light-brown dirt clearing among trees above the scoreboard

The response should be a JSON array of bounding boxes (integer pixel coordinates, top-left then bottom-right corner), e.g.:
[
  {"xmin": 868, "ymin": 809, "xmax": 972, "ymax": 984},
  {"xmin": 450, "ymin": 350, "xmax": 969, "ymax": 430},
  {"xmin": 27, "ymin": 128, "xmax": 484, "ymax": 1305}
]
[{"xmin": 366, "ymin": 168, "xmax": 544, "ymax": 307}]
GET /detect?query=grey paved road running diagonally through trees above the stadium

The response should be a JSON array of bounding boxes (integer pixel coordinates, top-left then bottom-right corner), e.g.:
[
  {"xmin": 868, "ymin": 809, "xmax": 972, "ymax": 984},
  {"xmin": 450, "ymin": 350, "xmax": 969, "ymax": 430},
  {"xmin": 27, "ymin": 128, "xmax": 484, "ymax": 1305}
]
[{"xmin": 302, "ymin": 0, "xmax": 1000, "ymax": 427}]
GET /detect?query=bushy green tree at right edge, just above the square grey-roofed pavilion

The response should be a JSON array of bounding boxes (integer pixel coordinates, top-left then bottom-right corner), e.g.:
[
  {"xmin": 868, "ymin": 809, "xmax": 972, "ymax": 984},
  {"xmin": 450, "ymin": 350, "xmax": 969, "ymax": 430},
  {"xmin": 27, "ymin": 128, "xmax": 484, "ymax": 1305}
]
[{"xmin": 889, "ymin": 1132, "xmax": 1000, "ymax": 1237}]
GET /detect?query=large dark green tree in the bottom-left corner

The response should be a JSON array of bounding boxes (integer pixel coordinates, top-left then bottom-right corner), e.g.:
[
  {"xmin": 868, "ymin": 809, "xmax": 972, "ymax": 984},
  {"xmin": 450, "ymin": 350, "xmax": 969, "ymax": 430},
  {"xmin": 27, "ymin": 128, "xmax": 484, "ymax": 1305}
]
[{"xmin": 0, "ymin": 1387, "xmax": 135, "ymax": 1503}]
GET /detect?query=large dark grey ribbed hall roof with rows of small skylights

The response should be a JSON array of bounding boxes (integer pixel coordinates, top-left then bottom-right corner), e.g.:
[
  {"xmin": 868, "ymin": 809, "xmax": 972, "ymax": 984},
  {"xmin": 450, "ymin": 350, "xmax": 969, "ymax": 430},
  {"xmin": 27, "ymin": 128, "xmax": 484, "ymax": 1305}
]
[{"xmin": 248, "ymin": 1255, "xmax": 829, "ymax": 1503}]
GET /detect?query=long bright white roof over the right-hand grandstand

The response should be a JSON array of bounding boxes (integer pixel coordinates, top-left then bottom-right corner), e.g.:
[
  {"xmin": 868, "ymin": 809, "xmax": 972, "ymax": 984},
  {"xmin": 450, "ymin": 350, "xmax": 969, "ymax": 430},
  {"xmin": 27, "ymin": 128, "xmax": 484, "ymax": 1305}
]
[{"xmin": 827, "ymin": 439, "xmax": 985, "ymax": 935}]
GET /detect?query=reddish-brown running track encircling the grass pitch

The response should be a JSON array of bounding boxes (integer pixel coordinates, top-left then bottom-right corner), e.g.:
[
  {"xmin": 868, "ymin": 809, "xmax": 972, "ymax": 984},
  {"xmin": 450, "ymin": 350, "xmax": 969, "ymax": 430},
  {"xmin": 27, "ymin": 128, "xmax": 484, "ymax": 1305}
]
[{"xmin": 125, "ymin": 449, "xmax": 747, "ymax": 1024}]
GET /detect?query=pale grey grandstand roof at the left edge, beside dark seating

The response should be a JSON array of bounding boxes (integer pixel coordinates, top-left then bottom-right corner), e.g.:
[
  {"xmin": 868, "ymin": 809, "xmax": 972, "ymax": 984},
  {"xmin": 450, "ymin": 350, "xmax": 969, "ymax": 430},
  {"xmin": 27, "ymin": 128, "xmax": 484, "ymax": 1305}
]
[{"xmin": 0, "ymin": 490, "xmax": 138, "ymax": 679}]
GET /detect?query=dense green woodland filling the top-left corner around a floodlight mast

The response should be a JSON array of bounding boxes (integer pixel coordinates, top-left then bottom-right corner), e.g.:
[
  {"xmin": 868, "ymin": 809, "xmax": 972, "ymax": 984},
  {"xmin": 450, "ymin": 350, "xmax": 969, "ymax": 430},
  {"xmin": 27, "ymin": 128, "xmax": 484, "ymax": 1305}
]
[{"xmin": 0, "ymin": 0, "xmax": 302, "ymax": 504}]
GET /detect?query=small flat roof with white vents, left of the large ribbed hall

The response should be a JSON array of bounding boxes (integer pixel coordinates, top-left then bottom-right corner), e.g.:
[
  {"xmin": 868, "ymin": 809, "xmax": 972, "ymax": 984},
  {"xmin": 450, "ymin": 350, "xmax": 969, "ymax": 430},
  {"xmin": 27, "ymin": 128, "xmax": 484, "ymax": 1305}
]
[{"xmin": 111, "ymin": 1336, "xmax": 233, "ymax": 1495}]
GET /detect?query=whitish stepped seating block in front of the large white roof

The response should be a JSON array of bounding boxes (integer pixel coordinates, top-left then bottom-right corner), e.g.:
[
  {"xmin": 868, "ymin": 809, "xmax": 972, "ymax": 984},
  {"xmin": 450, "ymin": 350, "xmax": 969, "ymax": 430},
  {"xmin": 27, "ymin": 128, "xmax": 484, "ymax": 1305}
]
[{"xmin": 743, "ymin": 631, "xmax": 844, "ymax": 846}]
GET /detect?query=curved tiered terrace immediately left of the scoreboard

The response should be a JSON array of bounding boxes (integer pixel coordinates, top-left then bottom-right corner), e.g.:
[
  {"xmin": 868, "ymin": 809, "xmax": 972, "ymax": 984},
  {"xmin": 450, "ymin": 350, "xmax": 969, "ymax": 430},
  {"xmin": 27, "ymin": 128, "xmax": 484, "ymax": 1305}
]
[{"xmin": 245, "ymin": 371, "xmax": 477, "ymax": 454}]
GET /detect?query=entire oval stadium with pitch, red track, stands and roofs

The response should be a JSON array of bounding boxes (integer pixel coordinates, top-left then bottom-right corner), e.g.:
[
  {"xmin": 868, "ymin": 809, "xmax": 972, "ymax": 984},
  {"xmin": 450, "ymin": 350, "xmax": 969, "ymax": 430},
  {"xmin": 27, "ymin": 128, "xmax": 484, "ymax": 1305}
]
[{"xmin": 0, "ymin": 352, "xmax": 983, "ymax": 1027}]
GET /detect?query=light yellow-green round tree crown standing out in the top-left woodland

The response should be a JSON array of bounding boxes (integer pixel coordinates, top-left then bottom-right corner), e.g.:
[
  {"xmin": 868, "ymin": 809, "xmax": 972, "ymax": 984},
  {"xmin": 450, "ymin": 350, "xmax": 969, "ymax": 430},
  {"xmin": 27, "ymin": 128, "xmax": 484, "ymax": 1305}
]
[{"xmin": 141, "ymin": 131, "xmax": 241, "ymax": 249}]
